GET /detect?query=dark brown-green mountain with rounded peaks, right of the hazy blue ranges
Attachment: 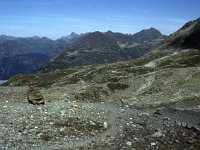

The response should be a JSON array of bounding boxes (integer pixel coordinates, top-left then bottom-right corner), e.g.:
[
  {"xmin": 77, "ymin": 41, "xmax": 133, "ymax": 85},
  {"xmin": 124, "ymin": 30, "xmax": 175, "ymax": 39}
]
[{"xmin": 41, "ymin": 28, "xmax": 166, "ymax": 71}]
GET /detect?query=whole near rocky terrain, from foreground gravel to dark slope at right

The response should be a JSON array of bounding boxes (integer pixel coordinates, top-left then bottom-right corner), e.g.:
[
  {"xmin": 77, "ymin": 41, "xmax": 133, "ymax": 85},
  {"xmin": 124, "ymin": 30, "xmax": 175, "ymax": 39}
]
[{"xmin": 0, "ymin": 19, "xmax": 200, "ymax": 150}]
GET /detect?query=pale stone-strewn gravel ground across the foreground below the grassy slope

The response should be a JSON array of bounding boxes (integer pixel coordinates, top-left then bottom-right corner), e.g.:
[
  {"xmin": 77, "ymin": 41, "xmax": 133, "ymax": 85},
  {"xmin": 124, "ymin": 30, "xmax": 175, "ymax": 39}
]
[{"xmin": 0, "ymin": 87, "xmax": 200, "ymax": 150}]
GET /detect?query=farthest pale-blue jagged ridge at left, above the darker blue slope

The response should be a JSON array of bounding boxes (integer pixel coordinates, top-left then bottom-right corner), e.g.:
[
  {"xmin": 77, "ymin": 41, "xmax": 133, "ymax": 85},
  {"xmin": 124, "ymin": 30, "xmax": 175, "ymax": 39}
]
[{"xmin": 0, "ymin": 32, "xmax": 78, "ymax": 57}]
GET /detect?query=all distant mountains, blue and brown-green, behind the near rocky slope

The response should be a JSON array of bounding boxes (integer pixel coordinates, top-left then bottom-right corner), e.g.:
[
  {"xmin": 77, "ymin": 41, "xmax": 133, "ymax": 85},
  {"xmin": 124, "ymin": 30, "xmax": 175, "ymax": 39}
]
[{"xmin": 0, "ymin": 28, "xmax": 166, "ymax": 79}]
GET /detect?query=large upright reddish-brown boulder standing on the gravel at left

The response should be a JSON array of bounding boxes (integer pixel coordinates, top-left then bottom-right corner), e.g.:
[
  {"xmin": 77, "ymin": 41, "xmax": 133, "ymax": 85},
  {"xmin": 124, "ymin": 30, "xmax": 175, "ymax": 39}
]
[{"xmin": 27, "ymin": 87, "xmax": 44, "ymax": 105}]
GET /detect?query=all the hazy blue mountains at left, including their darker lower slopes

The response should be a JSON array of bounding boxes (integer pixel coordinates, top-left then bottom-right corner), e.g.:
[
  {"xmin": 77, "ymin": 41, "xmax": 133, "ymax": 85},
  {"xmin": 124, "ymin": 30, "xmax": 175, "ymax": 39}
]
[{"xmin": 0, "ymin": 32, "xmax": 79, "ymax": 79}]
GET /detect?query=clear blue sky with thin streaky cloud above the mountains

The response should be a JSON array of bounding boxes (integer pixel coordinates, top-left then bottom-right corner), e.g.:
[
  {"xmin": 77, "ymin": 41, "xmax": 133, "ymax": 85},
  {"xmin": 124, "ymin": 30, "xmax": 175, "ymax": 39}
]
[{"xmin": 0, "ymin": 0, "xmax": 200, "ymax": 39}]
